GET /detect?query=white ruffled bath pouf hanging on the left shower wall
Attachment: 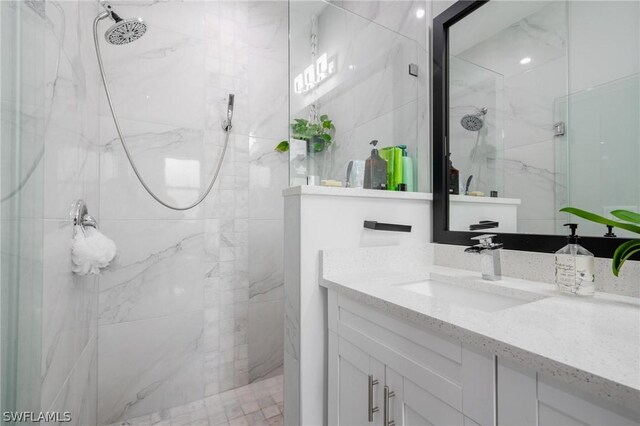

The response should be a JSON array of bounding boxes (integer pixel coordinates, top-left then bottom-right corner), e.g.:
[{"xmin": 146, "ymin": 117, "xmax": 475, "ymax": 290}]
[{"xmin": 71, "ymin": 225, "xmax": 116, "ymax": 275}]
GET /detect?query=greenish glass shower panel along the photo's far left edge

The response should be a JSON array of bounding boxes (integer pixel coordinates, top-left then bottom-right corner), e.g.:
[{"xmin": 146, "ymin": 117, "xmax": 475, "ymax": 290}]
[{"xmin": 0, "ymin": 1, "xmax": 46, "ymax": 424}]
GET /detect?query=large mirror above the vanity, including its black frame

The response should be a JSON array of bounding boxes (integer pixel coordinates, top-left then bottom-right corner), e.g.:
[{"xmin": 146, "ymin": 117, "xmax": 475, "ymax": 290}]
[{"xmin": 432, "ymin": 0, "xmax": 640, "ymax": 259}]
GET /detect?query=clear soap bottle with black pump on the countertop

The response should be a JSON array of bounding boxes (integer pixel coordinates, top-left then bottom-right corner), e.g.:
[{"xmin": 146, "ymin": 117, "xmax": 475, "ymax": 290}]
[{"xmin": 556, "ymin": 223, "xmax": 596, "ymax": 296}]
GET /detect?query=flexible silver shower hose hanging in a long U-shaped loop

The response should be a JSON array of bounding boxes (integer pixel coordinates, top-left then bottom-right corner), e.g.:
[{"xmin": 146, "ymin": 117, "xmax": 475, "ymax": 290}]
[{"xmin": 93, "ymin": 15, "xmax": 231, "ymax": 211}]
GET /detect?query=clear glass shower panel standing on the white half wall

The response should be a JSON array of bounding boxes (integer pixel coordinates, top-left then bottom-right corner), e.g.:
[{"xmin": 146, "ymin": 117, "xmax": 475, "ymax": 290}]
[{"xmin": 289, "ymin": 1, "xmax": 420, "ymax": 186}]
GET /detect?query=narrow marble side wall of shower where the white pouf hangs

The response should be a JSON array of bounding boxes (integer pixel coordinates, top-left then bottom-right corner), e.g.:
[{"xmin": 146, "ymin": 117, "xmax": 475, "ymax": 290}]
[{"xmin": 38, "ymin": 1, "xmax": 100, "ymax": 425}]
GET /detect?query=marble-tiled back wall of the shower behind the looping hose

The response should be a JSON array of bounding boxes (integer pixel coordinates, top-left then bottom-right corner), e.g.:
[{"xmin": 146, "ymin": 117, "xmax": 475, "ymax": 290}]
[{"xmin": 98, "ymin": 1, "xmax": 288, "ymax": 424}]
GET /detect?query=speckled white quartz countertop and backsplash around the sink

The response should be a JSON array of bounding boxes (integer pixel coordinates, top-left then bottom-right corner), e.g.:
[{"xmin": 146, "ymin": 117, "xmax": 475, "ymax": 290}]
[{"xmin": 321, "ymin": 248, "xmax": 640, "ymax": 412}]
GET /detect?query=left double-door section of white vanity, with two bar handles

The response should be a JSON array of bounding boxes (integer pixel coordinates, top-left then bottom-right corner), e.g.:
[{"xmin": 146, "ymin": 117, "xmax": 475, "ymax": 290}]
[{"xmin": 327, "ymin": 290, "xmax": 495, "ymax": 426}]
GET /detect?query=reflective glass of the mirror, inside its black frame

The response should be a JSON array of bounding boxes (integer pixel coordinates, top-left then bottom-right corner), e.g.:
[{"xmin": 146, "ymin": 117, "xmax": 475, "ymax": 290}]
[{"xmin": 448, "ymin": 1, "xmax": 640, "ymax": 237}]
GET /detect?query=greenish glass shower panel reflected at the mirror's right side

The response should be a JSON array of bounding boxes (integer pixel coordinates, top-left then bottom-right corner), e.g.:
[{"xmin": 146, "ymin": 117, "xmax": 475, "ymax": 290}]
[{"xmin": 556, "ymin": 74, "xmax": 640, "ymax": 237}]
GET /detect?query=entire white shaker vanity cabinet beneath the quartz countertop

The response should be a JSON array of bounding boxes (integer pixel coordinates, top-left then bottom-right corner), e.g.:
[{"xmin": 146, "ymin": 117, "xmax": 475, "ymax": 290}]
[{"xmin": 327, "ymin": 289, "xmax": 640, "ymax": 426}]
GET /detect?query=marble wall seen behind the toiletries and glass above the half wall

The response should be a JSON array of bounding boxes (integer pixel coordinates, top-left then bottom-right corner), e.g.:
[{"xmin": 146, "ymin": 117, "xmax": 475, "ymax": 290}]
[{"xmin": 291, "ymin": 0, "xmax": 430, "ymax": 191}]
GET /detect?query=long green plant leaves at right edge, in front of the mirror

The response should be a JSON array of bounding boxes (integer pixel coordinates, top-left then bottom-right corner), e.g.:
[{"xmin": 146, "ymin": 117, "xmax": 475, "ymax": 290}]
[{"xmin": 560, "ymin": 207, "xmax": 640, "ymax": 277}]
